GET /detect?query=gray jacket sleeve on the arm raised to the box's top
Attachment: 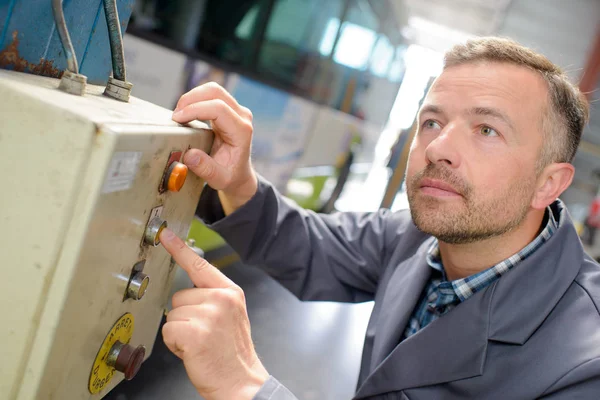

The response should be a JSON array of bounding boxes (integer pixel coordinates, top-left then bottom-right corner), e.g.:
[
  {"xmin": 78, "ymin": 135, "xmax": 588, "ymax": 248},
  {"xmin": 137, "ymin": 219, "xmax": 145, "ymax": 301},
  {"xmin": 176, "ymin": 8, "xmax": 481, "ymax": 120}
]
[{"xmin": 196, "ymin": 177, "xmax": 411, "ymax": 302}]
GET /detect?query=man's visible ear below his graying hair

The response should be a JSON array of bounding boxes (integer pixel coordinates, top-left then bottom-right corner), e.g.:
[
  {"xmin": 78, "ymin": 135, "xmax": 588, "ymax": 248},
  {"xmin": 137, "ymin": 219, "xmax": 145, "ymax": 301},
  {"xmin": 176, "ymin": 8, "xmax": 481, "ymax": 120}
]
[{"xmin": 531, "ymin": 163, "xmax": 575, "ymax": 210}]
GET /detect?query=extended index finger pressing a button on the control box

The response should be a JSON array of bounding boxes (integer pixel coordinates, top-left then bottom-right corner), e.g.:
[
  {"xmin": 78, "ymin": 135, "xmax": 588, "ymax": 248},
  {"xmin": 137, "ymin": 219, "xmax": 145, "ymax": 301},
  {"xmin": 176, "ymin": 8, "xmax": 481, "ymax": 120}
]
[{"xmin": 160, "ymin": 228, "xmax": 235, "ymax": 289}]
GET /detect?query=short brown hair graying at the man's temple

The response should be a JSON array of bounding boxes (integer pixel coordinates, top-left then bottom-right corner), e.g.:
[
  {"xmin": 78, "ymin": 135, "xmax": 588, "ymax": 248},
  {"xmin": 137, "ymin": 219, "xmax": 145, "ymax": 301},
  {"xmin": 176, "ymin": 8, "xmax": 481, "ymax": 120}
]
[{"xmin": 444, "ymin": 37, "xmax": 589, "ymax": 170}]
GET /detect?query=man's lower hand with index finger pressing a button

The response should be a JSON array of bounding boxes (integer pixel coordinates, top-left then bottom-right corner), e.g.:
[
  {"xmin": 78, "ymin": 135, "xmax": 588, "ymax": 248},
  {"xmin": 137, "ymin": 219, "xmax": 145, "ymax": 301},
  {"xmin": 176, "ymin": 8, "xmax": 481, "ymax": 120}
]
[{"xmin": 160, "ymin": 229, "xmax": 269, "ymax": 400}]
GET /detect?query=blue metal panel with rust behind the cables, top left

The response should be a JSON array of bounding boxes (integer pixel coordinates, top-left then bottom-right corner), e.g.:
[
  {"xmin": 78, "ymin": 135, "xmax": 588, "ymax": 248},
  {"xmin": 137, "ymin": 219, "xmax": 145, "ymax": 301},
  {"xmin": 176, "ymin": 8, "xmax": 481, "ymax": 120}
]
[{"xmin": 0, "ymin": 0, "xmax": 134, "ymax": 84}]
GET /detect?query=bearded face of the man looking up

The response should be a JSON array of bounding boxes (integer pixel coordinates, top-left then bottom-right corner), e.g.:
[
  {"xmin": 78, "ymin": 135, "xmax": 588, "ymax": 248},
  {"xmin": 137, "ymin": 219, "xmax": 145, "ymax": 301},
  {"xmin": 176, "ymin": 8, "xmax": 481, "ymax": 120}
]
[{"xmin": 407, "ymin": 63, "xmax": 547, "ymax": 244}]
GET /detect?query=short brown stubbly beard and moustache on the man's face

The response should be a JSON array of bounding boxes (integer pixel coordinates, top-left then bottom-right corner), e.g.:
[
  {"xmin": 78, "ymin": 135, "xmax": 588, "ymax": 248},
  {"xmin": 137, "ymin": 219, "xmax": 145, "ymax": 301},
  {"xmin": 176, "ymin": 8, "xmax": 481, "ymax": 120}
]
[{"xmin": 407, "ymin": 164, "xmax": 535, "ymax": 244}]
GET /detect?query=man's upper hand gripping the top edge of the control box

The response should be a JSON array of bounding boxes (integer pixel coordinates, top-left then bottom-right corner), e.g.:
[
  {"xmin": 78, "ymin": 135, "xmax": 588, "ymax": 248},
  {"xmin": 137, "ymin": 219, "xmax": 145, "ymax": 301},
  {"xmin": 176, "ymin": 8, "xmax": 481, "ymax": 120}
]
[{"xmin": 173, "ymin": 83, "xmax": 257, "ymax": 215}]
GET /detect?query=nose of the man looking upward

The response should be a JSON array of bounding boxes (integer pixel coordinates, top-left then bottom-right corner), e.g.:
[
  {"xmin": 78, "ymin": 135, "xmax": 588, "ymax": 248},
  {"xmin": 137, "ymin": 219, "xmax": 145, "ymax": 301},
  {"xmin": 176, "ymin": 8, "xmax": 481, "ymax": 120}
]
[{"xmin": 425, "ymin": 123, "xmax": 464, "ymax": 168}]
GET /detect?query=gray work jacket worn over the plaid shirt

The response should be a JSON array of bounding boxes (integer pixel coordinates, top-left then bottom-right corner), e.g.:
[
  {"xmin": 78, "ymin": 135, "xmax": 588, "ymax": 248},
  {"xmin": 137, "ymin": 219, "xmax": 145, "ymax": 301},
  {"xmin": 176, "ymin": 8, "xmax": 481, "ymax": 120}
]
[{"xmin": 197, "ymin": 178, "xmax": 600, "ymax": 400}]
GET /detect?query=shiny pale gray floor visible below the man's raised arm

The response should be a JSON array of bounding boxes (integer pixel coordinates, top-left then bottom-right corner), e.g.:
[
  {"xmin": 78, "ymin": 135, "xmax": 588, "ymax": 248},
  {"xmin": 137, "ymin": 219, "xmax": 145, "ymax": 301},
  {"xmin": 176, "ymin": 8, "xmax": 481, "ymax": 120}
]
[{"xmin": 105, "ymin": 263, "xmax": 372, "ymax": 400}]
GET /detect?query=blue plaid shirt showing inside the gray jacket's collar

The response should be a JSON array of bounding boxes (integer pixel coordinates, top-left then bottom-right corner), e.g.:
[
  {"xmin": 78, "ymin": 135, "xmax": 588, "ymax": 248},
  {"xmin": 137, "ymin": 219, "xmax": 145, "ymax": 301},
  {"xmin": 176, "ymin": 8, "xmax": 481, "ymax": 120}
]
[{"xmin": 403, "ymin": 200, "xmax": 563, "ymax": 339}]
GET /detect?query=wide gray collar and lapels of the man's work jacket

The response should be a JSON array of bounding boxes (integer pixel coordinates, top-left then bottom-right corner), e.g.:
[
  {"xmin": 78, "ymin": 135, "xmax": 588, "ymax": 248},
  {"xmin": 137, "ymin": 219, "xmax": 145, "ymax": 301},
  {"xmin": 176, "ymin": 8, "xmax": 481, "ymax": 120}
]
[{"xmin": 356, "ymin": 202, "xmax": 583, "ymax": 399}]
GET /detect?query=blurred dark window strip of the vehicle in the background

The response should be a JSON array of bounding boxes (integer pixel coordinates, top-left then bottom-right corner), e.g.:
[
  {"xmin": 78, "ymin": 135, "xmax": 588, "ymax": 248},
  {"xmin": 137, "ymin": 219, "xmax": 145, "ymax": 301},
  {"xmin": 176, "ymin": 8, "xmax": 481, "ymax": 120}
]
[{"xmin": 130, "ymin": 0, "xmax": 404, "ymax": 119}]
